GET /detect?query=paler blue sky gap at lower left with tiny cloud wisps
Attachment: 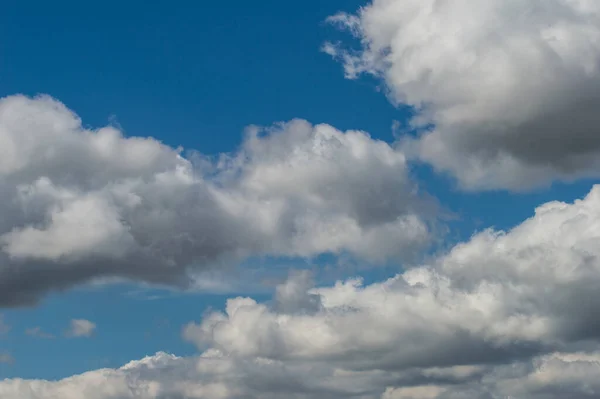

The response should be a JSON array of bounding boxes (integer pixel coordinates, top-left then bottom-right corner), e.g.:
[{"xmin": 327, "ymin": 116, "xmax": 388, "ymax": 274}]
[{"xmin": 0, "ymin": 285, "xmax": 261, "ymax": 379}]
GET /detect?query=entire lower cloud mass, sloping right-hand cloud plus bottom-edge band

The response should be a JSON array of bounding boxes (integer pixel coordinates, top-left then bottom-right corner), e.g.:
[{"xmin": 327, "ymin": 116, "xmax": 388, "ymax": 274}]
[{"xmin": 0, "ymin": 186, "xmax": 600, "ymax": 399}]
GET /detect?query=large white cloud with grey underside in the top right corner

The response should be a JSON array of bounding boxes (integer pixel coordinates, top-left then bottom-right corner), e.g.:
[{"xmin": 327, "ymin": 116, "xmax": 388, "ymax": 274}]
[{"xmin": 324, "ymin": 0, "xmax": 600, "ymax": 190}]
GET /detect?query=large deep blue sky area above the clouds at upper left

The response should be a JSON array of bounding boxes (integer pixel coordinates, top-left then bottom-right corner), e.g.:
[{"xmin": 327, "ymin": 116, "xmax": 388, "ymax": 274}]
[{"xmin": 0, "ymin": 0, "xmax": 390, "ymax": 153}]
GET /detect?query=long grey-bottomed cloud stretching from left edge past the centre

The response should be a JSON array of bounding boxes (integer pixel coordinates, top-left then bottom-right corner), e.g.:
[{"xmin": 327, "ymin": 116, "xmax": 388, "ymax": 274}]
[{"xmin": 0, "ymin": 96, "xmax": 434, "ymax": 306}]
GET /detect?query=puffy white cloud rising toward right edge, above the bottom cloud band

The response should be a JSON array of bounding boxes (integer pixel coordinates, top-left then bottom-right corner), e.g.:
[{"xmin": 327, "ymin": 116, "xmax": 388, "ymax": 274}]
[{"xmin": 185, "ymin": 186, "xmax": 600, "ymax": 369}]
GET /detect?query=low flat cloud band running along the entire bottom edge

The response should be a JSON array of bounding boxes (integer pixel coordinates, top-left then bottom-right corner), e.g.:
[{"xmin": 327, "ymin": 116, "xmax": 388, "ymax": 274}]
[{"xmin": 0, "ymin": 350, "xmax": 600, "ymax": 399}]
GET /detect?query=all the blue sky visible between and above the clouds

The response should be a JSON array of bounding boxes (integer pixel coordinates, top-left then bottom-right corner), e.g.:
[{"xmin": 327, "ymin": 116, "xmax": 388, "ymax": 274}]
[{"xmin": 0, "ymin": 0, "xmax": 591, "ymax": 390}]
